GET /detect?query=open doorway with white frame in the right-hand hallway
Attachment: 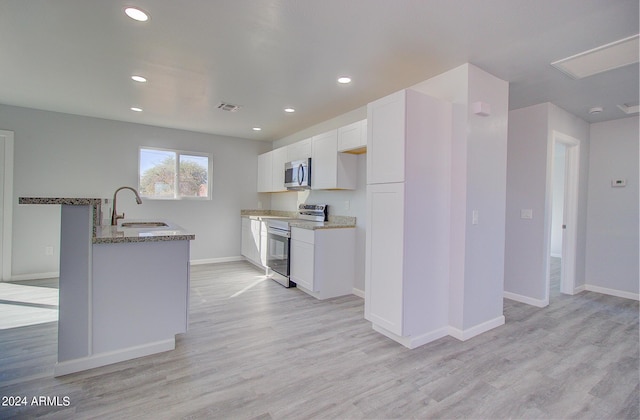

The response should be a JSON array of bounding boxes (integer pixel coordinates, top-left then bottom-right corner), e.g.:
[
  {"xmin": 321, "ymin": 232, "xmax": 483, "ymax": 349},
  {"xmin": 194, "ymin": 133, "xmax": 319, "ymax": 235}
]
[{"xmin": 546, "ymin": 131, "xmax": 580, "ymax": 302}]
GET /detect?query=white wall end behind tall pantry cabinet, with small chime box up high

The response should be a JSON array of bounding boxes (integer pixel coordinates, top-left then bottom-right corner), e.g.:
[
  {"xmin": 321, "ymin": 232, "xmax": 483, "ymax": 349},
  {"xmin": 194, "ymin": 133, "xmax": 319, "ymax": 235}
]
[{"xmin": 412, "ymin": 64, "xmax": 509, "ymax": 331}]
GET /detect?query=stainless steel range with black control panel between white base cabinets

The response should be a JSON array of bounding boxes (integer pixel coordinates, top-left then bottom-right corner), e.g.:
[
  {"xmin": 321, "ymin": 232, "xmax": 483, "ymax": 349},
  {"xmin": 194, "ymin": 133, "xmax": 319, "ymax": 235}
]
[{"xmin": 267, "ymin": 204, "xmax": 328, "ymax": 287}]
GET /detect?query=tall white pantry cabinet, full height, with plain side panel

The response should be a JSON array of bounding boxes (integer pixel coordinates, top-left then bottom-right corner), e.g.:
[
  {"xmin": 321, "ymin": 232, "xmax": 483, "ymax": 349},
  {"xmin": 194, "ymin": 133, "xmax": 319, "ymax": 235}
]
[{"xmin": 365, "ymin": 90, "xmax": 451, "ymax": 348}]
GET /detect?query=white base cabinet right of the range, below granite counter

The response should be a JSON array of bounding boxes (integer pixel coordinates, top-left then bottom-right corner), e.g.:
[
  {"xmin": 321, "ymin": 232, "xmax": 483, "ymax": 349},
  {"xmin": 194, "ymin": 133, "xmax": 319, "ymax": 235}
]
[{"xmin": 289, "ymin": 227, "xmax": 355, "ymax": 299}]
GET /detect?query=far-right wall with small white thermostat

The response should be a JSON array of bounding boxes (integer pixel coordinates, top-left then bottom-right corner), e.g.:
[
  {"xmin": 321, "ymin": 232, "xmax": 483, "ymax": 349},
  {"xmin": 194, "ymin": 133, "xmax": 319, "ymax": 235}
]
[{"xmin": 585, "ymin": 117, "xmax": 640, "ymax": 299}]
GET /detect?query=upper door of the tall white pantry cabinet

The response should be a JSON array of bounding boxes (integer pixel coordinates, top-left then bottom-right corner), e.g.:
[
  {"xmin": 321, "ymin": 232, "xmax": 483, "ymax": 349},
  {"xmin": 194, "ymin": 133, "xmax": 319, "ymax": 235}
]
[{"xmin": 367, "ymin": 90, "xmax": 406, "ymax": 184}]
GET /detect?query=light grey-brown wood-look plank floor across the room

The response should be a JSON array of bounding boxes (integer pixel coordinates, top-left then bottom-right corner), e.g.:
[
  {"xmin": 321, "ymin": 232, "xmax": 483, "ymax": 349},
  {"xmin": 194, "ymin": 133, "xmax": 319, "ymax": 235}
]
[{"xmin": 0, "ymin": 262, "xmax": 639, "ymax": 419}]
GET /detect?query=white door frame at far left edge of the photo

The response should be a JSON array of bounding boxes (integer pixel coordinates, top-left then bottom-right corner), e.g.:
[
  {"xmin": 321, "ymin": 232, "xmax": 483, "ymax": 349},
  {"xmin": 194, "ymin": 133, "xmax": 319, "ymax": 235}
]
[{"xmin": 0, "ymin": 130, "xmax": 14, "ymax": 281}]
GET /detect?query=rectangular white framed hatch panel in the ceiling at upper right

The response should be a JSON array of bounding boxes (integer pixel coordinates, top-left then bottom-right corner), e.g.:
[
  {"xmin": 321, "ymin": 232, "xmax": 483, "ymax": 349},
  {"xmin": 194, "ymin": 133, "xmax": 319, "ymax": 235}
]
[{"xmin": 551, "ymin": 35, "xmax": 640, "ymax": 79}]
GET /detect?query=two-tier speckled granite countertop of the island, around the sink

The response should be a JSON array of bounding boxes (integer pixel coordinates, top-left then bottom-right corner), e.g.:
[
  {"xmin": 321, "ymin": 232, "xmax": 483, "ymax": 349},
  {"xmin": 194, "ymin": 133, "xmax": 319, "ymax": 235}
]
[{"xmin": 18, "ymin": 197, "xmax": 196, "ymax": 244}]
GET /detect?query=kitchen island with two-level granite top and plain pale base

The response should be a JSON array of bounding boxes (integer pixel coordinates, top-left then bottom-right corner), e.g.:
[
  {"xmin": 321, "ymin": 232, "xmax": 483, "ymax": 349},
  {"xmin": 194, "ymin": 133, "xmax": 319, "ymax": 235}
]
[{"xmin": 19, "ymin": 197, "xmax": 195, "ymax": 376}]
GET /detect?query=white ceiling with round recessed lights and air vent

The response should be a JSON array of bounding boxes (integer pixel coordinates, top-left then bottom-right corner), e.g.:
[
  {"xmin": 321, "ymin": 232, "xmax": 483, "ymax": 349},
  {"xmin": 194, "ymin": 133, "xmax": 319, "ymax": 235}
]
[{"xmin": 0, "ymin": 0, "xmax": 640, "ymax": 140}]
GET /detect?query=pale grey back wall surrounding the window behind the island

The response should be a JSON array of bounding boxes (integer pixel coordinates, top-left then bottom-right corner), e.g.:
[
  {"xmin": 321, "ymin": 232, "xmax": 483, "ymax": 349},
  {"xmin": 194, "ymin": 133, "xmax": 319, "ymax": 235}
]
[{"xmin": 0, "ymin": 105, "xmax": 271, "ymax": 278}]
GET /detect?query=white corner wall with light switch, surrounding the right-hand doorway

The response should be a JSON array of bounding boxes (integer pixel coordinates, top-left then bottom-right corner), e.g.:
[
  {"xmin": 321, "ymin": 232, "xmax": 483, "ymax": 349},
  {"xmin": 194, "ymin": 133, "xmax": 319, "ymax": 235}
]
[{"xmin": 504, "ymin": 103, "xmax": 589, "ymax": 306}]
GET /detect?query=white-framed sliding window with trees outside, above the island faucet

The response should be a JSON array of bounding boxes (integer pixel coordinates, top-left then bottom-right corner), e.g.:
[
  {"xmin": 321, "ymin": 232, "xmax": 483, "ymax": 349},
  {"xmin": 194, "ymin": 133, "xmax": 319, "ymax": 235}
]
[{"xmin": 138, "ymin": 147, "xmax": 212, "ymax": 200}]
